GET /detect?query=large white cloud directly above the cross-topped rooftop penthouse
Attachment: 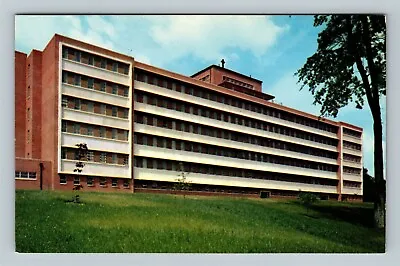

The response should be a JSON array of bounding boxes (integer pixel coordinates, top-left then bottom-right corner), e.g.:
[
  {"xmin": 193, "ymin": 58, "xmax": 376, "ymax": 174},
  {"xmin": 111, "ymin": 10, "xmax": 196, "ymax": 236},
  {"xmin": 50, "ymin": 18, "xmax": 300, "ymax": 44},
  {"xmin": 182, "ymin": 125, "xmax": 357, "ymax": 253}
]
[{"xmin": 146, "ymin": 15, "xmax": 287, "ymax": 61}]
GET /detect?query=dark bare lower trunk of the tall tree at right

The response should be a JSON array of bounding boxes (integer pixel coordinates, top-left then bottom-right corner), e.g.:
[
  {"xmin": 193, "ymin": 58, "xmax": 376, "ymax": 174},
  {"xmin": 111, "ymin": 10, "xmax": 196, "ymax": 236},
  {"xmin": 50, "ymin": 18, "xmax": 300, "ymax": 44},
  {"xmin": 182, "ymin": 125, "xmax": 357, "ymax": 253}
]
[{"xmin": 373, "ymin": 110, "xmax": 386, "ymax": 228}]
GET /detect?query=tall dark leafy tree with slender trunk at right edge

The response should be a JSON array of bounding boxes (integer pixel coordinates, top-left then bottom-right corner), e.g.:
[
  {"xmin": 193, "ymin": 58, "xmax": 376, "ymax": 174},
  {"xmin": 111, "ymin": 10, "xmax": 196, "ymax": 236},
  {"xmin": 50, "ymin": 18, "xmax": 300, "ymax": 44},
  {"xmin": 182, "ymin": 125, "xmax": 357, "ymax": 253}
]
[{"xmin": 295, "ymin": 15, "xmax": 386, "ymax": 228}]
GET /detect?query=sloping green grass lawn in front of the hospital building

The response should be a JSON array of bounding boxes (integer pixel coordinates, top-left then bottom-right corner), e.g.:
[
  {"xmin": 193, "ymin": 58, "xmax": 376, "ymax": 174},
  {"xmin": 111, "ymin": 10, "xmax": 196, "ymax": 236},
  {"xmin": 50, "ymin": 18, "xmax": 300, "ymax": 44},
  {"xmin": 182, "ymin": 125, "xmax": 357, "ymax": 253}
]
[{"xmin": 15, "ymin": 191, "xmax": 385, "ymax": 253}]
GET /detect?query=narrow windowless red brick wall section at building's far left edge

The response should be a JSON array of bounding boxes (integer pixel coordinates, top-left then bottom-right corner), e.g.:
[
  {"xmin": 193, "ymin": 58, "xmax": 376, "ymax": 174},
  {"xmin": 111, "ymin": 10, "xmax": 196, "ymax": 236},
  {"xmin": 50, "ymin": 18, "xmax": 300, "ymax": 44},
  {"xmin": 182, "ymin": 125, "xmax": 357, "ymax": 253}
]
[{"xmin": 15, "ymin": 52, "xmax": 26, "ymax": 157}]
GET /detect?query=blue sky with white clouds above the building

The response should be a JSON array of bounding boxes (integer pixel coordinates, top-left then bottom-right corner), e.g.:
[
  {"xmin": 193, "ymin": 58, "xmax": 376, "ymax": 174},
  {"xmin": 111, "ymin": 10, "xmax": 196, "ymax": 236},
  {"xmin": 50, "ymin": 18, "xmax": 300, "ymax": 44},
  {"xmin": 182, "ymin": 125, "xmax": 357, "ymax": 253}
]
[{"xmin": 15, "ymin": 15, "xmax": 386, "ymax": 175}]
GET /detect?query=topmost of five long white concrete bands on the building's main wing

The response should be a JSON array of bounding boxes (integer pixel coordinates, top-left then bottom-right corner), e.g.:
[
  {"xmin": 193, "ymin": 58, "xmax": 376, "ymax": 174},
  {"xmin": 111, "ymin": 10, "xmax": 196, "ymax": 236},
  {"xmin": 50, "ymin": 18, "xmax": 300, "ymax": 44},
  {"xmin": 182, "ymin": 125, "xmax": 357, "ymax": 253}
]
[{"xmin": 135, "ymin": 80, "xmax": 338, "ymax": 139}]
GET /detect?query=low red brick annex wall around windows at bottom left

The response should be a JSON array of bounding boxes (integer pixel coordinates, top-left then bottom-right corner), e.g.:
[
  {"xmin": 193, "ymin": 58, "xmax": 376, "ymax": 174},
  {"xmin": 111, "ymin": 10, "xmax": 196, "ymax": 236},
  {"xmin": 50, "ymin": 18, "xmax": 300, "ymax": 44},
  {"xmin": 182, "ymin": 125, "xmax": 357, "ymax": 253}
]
[{"xmin": 15, "ymin": 158, "xmax": 52, "ymax": 190}]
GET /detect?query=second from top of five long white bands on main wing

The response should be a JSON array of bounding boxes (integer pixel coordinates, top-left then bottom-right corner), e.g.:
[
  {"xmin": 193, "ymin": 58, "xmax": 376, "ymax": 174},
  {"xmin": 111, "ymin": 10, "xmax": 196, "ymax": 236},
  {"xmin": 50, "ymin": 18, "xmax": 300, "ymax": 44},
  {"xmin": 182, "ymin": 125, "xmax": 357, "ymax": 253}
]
[{"xmin": 134, "ymin": 102, "xmax": 337, "ymax": 152}]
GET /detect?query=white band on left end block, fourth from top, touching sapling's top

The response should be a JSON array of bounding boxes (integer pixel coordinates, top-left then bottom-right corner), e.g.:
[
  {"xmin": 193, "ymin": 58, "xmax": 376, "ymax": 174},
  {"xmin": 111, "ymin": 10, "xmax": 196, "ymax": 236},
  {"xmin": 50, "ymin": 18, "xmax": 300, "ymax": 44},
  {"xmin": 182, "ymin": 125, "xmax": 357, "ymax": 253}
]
[{"xmin": 61, "ymin": 132, "xmax": 130, "ymax": 154}]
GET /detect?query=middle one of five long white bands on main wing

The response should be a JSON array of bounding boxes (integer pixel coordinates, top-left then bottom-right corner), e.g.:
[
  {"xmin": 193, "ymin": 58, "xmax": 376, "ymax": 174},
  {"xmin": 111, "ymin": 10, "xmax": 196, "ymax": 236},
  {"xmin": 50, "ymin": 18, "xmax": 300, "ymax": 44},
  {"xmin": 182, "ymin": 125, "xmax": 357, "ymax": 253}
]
[{"xmin": 135, "ymin": 123, "xmax": 337, "ymax": 165}]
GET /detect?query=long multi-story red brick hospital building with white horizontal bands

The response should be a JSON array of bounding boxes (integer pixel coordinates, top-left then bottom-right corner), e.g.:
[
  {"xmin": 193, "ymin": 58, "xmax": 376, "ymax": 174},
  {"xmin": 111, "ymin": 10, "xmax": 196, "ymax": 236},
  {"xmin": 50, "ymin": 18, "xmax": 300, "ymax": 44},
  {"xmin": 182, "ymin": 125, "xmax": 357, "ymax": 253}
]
[{"xmin": 15, "ymin": 34, "xmax": 363, "ymax": 200}]
